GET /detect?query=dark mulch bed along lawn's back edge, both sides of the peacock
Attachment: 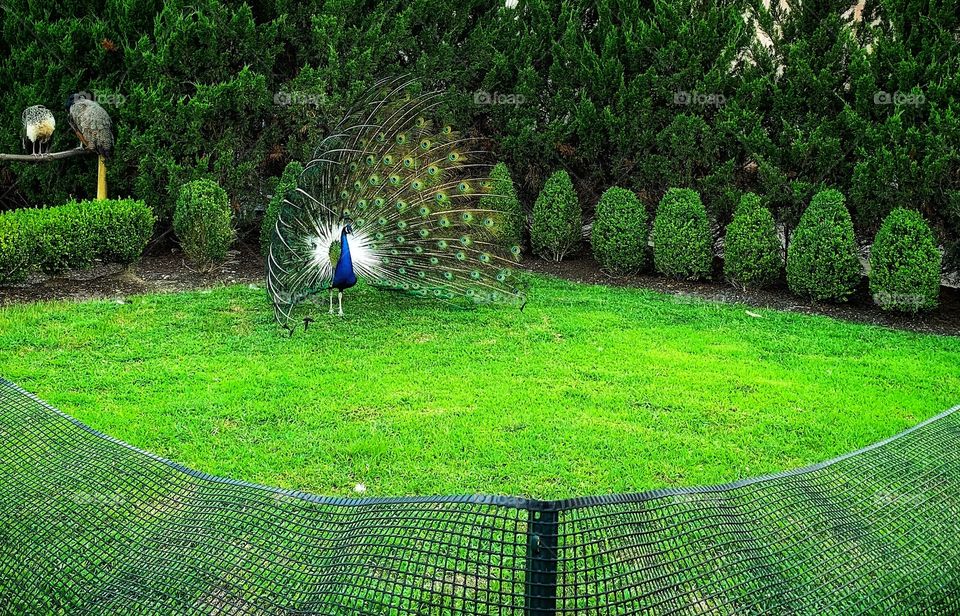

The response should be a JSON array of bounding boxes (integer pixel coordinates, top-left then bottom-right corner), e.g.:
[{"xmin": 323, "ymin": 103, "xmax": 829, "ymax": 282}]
[{"xmin": 0, "ymin": 243, "xmax": 960, "ymax": 336}]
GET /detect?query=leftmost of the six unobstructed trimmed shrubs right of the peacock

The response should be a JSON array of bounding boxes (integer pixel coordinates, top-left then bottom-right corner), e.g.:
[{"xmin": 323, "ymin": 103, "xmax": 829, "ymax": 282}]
[{"xmin": 530, "ymin": 171, "xmax": 583, "ymax": 261}]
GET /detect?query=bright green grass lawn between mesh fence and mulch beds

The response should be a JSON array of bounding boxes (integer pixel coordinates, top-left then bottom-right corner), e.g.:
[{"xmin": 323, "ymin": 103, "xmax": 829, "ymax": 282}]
[{"xmin": 0, "ymin": 278, "xmax": 960, "ymax": 498}]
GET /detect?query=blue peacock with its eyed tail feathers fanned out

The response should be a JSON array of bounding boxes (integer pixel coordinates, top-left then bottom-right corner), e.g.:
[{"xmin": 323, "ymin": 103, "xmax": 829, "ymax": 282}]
[{"xmin": 267, "ymin": 78, "xmax": 526, "ymax": 333}]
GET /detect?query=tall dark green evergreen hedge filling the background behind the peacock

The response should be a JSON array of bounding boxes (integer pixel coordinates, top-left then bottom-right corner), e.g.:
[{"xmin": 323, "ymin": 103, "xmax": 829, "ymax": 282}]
[{"xmin": 0, "ymin": 0, "xmax": 960, "ymax": 264}]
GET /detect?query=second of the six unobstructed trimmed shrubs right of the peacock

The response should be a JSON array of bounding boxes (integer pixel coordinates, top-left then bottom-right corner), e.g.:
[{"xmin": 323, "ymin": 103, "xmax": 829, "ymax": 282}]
[{"xmin": 590, "ymin": 186, "xmax": 648, "ymax": 274}]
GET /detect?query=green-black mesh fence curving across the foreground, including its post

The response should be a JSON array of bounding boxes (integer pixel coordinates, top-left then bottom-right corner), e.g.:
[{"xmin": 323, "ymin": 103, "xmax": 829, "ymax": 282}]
[{"xmin": 0, "ymin": 380, "xmax": 960, "ymax": 615}]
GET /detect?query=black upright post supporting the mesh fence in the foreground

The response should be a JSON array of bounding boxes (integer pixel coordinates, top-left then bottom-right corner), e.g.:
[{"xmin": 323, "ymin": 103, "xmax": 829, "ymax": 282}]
[{"xmin": 524, "ymin": 503, "xmax": 560, "ymax": 616}]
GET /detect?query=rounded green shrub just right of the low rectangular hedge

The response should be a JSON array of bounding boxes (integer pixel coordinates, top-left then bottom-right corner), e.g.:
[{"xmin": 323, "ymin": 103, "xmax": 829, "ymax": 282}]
[{"xmin": 173, "ymin": 180, "xmax": 233, "ymax": 271}]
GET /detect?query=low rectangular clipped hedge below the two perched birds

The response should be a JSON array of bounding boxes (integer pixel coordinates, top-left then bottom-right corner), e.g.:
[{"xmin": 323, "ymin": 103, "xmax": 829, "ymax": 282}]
[{"xmin": 0, "ymin": 199, "xmax": 154, "ymax": 283}]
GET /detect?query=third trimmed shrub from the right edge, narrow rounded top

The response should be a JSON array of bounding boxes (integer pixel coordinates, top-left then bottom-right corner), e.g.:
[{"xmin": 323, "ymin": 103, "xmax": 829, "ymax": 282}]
[{"xmin": 723, "ymin": 193, "xmax": 783, "ymax": 288}]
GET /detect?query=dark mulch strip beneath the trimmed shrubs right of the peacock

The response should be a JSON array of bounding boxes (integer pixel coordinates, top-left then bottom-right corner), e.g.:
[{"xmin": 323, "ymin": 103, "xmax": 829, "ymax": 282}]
[{"xmin": 523, "ymin": 251, "xmax": 960, "ymax": 336}]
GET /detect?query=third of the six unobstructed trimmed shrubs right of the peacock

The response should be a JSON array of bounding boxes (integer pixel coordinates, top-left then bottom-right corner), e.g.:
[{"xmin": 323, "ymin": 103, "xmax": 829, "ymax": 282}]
[{"xmin": 653, "ymin": 188, "xmax": 713, "ymax": 280}]
